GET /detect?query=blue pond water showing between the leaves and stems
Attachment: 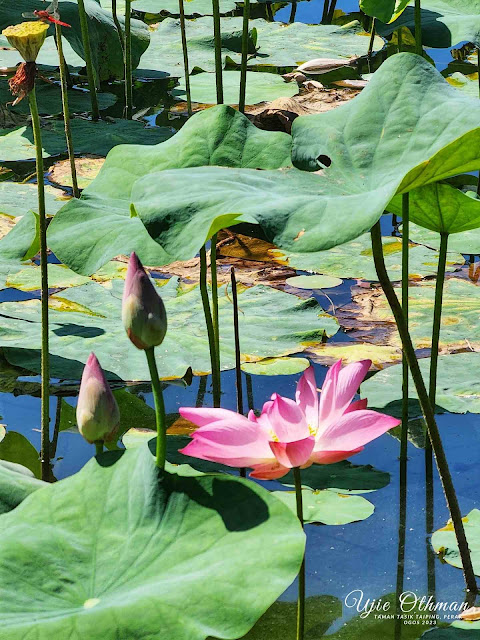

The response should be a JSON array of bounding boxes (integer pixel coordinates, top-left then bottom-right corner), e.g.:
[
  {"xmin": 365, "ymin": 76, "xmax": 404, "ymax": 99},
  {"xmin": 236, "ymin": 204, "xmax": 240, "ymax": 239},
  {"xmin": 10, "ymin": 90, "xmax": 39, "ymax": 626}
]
[{"xmin": 0, "ymin": 0, "xmax": 480, "ymax": 640}]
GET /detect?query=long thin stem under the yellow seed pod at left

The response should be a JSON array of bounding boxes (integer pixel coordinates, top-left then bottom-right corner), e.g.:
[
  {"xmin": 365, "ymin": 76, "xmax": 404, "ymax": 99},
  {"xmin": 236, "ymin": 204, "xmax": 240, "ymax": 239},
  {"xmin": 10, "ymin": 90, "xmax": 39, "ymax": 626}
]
[{"xmin": 28, "ymin": 87, "xmax": 50, "ymax": 480}]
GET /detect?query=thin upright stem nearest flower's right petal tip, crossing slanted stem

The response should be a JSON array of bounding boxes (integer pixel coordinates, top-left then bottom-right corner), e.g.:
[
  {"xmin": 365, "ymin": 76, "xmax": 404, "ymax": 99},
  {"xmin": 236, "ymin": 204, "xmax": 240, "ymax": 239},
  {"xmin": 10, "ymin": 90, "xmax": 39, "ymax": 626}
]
[{"xmin": 400, "ymin": 193, "xmax": 410, "ymax": 462}]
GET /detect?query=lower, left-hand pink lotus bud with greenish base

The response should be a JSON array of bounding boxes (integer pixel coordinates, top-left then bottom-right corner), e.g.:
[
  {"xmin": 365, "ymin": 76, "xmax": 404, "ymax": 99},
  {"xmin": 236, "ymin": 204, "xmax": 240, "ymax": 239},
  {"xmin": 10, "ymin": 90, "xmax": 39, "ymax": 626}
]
[{"xmin": 77, "ymin": 353, "xmax": 120, "ymax": 444}]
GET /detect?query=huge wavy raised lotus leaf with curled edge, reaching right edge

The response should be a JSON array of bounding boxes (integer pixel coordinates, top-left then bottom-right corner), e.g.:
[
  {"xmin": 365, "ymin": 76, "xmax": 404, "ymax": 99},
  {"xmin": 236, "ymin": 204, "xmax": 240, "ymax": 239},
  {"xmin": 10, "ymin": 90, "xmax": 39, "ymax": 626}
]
[{"xmin": 136, "ymin": 53, "xmax": 480, "ymax": 259}]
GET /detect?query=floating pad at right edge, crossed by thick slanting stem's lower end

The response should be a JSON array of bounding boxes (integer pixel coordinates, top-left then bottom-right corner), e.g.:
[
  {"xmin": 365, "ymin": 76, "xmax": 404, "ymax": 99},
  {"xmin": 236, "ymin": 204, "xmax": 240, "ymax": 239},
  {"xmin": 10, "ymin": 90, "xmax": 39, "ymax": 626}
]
[{"xmin": 432, "ymin": 509, "xmax": 480, "ymax": 576}]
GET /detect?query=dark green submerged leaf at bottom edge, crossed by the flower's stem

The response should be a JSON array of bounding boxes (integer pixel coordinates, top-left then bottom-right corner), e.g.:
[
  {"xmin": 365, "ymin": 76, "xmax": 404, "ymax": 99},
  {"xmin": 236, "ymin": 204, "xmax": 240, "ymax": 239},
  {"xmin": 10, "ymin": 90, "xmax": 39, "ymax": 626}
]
[{"xmin": 242, "ymin": 595, "xmax": 342, "ymax": 640}]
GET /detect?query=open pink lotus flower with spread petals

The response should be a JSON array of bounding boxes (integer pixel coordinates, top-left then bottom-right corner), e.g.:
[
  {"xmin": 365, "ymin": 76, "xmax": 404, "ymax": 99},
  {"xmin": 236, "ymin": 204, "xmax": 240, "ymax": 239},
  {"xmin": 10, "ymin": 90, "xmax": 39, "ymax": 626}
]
[{"xmin": 180, "ymin": 360, "xmax": 400, "ymax": 480}]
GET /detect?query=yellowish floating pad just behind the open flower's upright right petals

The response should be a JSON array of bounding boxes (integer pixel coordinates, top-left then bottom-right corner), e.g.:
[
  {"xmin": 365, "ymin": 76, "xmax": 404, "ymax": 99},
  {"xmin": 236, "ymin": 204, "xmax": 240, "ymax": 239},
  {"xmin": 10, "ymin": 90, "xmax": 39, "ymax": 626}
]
[{"xmin": 308, "ymin": 342, "xmax": 402, "ymax": 369}]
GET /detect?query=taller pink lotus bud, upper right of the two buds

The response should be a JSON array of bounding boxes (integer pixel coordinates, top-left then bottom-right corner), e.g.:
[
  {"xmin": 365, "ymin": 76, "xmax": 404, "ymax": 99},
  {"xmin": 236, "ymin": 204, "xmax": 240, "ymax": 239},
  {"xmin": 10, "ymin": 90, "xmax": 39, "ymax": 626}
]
[{"xmin": 122, "ymin": 253, "xmax": 167, "ymax": 349}]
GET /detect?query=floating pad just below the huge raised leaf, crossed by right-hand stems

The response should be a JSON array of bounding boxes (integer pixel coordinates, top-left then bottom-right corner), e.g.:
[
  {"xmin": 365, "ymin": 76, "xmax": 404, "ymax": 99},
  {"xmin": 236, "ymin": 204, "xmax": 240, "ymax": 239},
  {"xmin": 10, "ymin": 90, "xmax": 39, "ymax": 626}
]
[{"xmin": 278, "ymin": 233, "xmax": 464, "ymax": 281}]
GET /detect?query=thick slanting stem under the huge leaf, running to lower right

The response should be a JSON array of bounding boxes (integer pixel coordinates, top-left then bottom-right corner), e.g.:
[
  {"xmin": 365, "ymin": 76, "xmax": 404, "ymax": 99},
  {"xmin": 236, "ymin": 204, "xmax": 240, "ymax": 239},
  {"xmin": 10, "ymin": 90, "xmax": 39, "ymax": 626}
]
[{"xmin": 371, "ymin": 222, "xmax": 477, "ymax": 593}]
